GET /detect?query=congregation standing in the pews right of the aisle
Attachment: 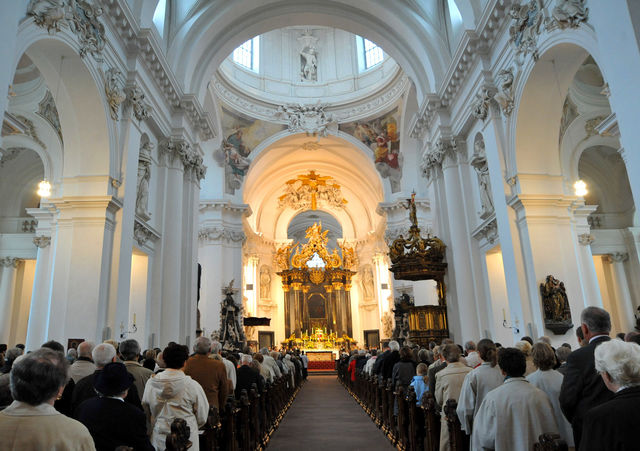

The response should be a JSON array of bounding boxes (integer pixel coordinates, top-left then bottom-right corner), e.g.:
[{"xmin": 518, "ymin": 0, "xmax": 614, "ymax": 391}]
[{"xmin": 339, "ymin": 307, "xmax": 640, "ymax": 451}]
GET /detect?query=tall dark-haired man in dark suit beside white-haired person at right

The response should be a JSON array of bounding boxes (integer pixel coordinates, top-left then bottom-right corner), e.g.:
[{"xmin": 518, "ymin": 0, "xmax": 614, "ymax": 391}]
[{"xmin": 560, "ymin": 307, "xmax": 612, "ymax": 449}]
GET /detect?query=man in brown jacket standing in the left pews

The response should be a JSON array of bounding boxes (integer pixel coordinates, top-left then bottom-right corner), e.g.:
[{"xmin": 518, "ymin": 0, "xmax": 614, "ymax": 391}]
[{"xmin": 184, "ymin": 337, "xmax": 228, "ymax": 409}]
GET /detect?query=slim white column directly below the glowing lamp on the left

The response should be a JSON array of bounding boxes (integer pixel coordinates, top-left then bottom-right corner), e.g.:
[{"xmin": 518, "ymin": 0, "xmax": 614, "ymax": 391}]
[{"xmin": 25, "ymin": 205, "xmax": 55, "ymax": 351}]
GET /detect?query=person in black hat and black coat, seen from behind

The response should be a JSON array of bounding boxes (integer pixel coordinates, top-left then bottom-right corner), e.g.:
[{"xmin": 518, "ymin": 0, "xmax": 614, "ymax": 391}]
[{"xmin": 76, "ymin": 362, "xmax": 153, "ymax": 451}]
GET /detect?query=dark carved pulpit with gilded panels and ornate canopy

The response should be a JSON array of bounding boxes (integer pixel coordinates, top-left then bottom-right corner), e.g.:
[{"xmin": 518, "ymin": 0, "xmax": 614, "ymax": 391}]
[{"xmin": 388, "ymin": 192, "xmax": 449, "ymax": 346}]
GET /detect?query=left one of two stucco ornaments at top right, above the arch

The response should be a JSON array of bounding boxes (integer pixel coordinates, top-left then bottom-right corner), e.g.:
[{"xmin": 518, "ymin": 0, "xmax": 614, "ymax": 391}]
[{"xmin": 509, "ymin": 0, "xmax": 544, "ymax": 63}]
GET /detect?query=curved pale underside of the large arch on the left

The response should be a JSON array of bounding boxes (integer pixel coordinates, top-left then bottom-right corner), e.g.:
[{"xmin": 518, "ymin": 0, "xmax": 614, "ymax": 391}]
[{"xmin": 13, "ymin": 26, "xmax": 117, "ymax": 186}]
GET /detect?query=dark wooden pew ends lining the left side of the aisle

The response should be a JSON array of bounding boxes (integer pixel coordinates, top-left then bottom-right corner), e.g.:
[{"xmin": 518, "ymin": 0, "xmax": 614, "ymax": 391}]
[{"xmin": 200, "ymin": 368, "xmax": 303, "ymax": 451}]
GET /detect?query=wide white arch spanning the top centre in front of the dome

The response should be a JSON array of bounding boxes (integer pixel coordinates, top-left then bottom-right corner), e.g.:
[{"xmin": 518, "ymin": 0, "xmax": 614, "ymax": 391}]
[{"xmin": 168, "ymin": 0, "xmax": 450, "ymax": 102}]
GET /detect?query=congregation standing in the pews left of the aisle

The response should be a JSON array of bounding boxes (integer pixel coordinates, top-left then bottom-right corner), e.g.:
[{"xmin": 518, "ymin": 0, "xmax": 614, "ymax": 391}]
[{"xmin": 0, "ymin": 337, "xmax": 308, "ymax": 451}]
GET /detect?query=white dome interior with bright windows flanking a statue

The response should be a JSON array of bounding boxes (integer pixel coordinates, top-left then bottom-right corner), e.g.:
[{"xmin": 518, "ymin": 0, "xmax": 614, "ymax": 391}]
[{"xmin": 214, "ymin": 26, "xmax": 401, "ymax": 106}]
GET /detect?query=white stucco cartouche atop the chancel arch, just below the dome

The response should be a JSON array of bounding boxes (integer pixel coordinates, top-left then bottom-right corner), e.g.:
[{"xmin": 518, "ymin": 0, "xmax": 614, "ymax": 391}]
[{"xmin": 275, "ymin": 103, "xmax": 338, "ymax": 137}]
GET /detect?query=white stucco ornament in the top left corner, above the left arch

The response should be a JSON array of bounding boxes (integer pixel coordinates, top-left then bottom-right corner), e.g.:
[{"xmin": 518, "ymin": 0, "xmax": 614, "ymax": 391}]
[{"xmin": 27, "ymin": 0, "xmax": 105, "ymax": 59}]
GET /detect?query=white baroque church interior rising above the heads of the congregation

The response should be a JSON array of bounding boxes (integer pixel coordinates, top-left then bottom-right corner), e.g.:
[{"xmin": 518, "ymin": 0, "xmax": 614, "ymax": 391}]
[{"xmin": 0, "ymin": 0, "xmax": 640, "ymax": 350}]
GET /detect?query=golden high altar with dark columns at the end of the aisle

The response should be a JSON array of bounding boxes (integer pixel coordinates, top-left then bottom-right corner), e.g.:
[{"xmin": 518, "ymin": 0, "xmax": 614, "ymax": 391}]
[{"xmin": 275, "ymin": 223, "xmax": 357, "ymax": 340}]
